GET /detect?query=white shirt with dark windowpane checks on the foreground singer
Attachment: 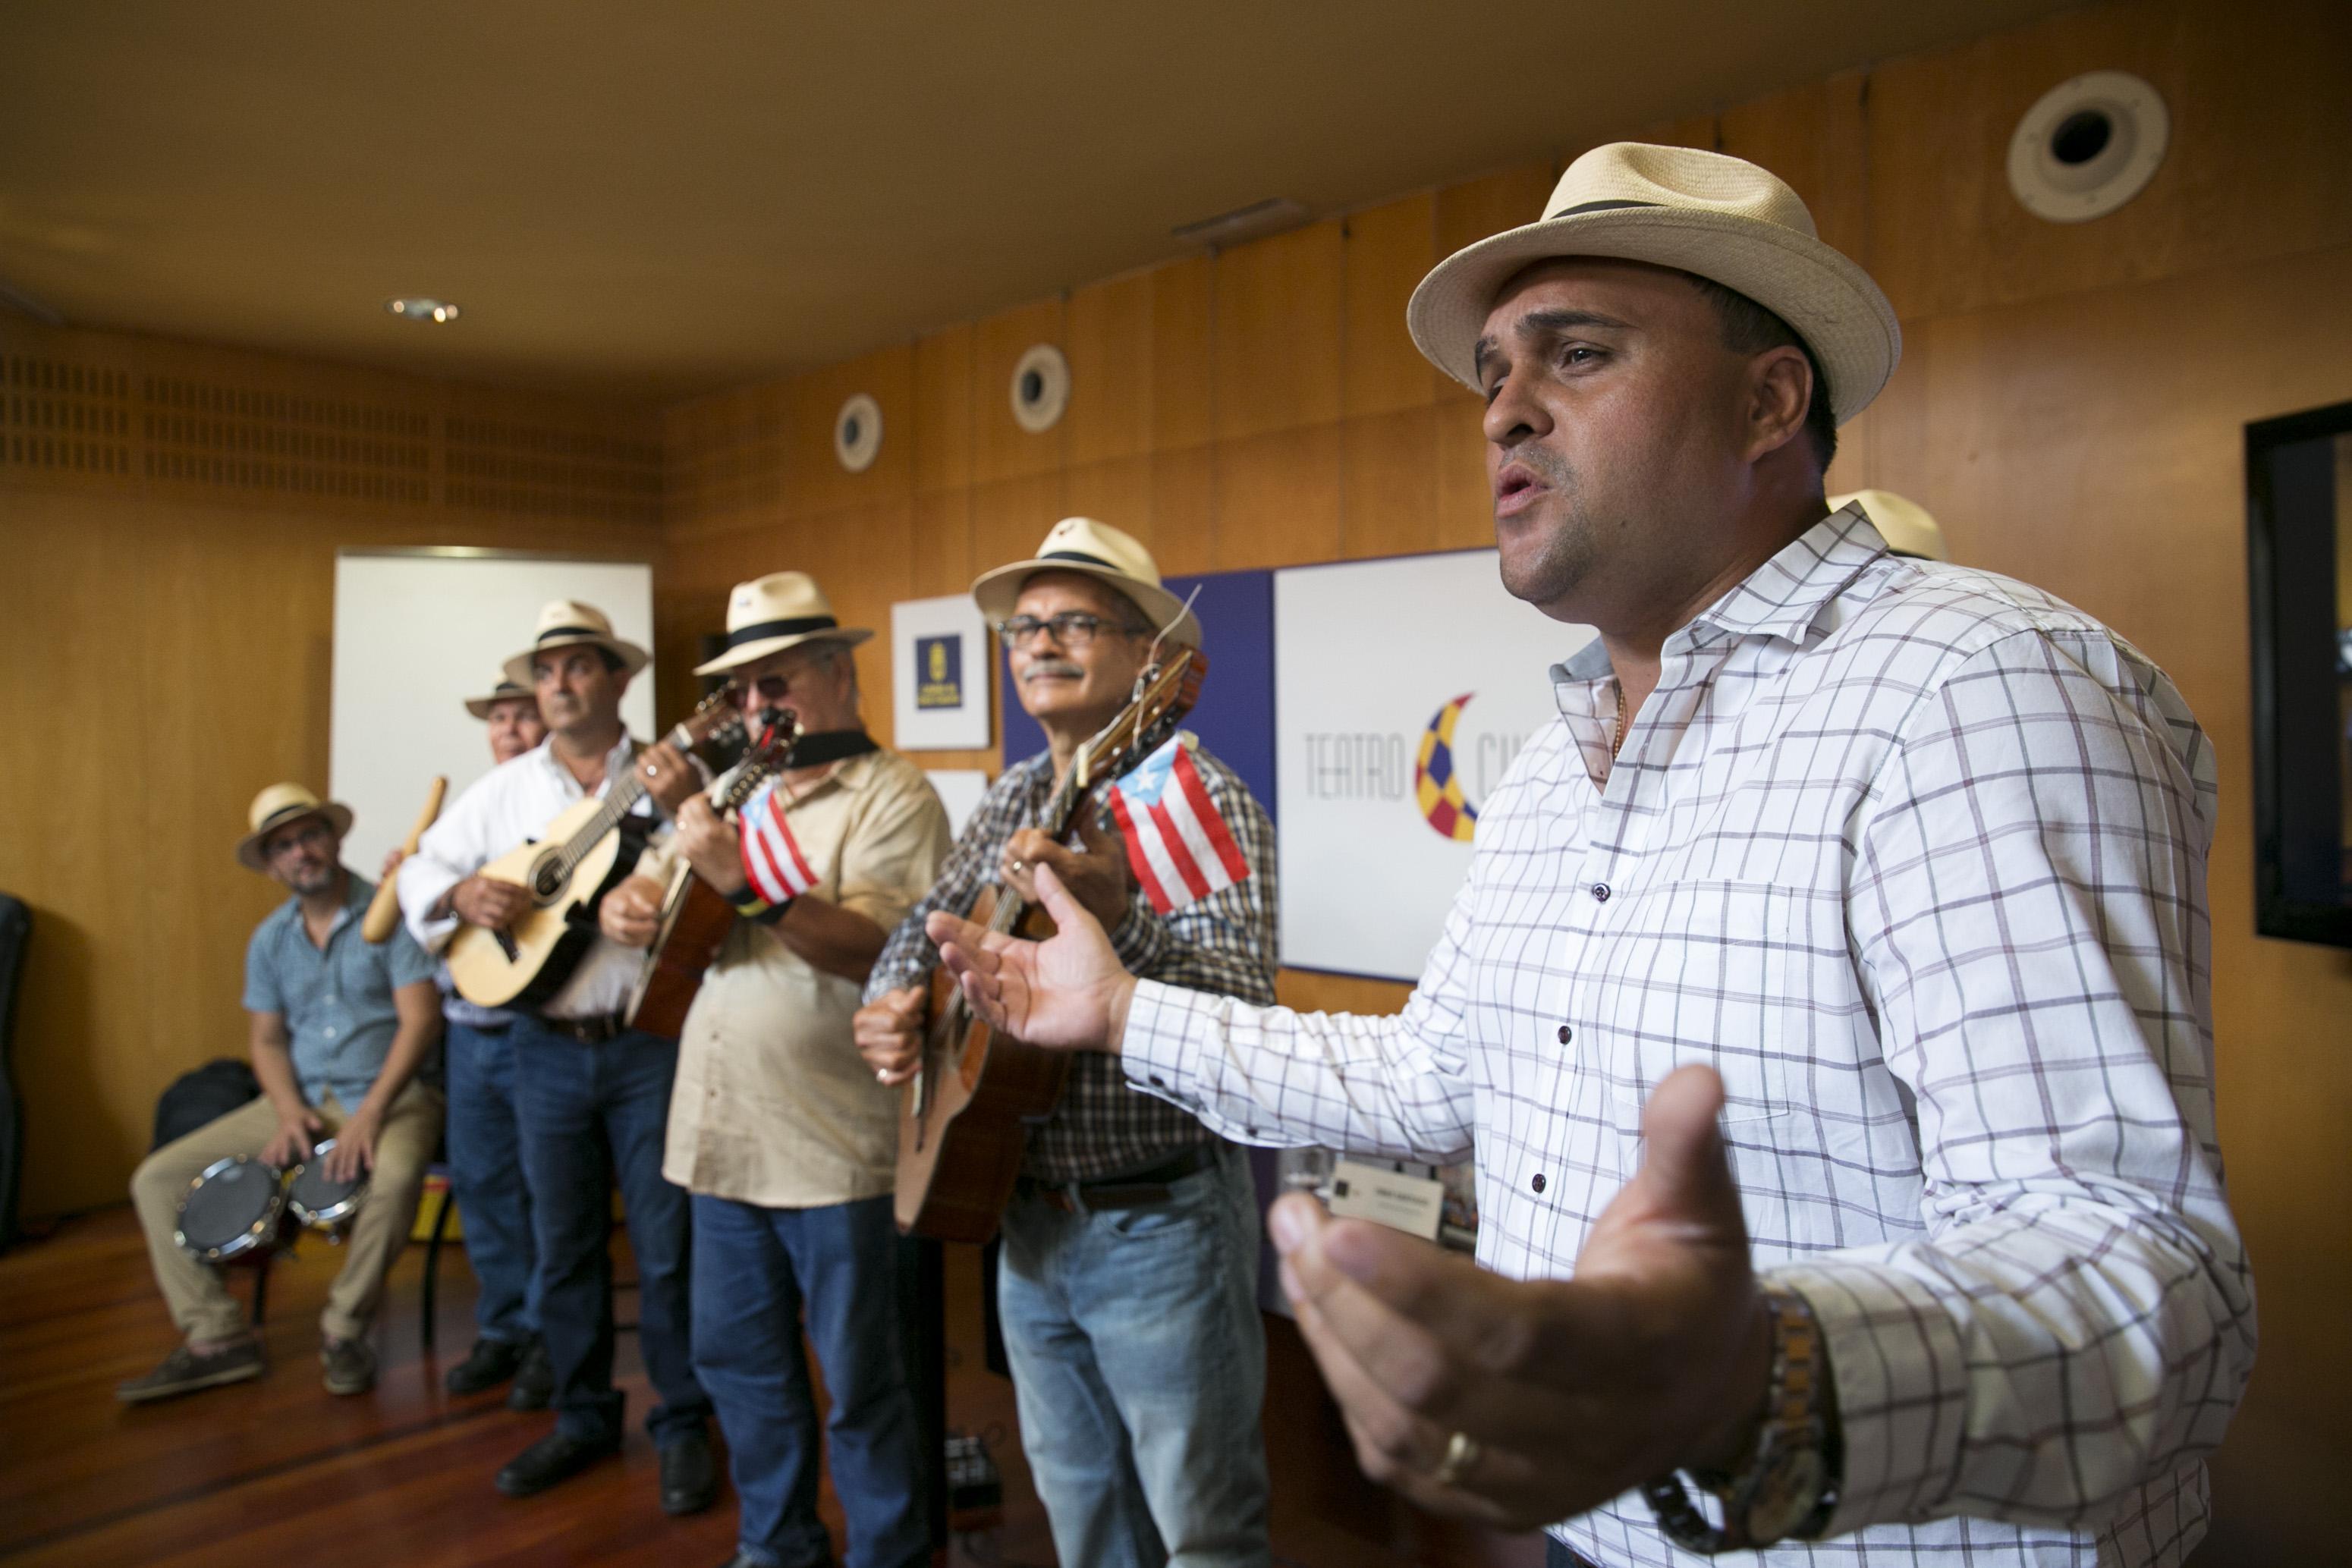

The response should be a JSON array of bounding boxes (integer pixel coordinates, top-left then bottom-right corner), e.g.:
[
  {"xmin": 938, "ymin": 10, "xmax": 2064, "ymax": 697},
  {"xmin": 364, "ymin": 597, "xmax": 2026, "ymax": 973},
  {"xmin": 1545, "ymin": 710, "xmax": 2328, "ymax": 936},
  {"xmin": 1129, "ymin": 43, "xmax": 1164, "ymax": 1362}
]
[{"xmin": 1124, "ymin": 510, "xmax": 2256, "ymax": 1568}]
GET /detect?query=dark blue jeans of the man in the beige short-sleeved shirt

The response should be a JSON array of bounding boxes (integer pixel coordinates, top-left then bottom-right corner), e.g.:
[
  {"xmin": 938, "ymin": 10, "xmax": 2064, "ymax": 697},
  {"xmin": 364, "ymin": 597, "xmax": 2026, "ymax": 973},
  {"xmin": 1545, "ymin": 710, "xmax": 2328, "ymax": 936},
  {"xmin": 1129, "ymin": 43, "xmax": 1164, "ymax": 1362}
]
[{"xmin": 694, "ymin": 1194, "xmax": 932, "ymax": 1568}]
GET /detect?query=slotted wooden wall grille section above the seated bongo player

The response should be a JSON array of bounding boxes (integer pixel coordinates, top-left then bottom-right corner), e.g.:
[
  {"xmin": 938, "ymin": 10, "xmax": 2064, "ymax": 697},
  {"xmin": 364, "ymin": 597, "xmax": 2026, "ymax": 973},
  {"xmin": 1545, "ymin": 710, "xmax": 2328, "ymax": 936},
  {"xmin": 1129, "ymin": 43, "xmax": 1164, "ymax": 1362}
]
[{"xmin": 139, "ymin": 376, "xmax": 432, "ymax": 505}]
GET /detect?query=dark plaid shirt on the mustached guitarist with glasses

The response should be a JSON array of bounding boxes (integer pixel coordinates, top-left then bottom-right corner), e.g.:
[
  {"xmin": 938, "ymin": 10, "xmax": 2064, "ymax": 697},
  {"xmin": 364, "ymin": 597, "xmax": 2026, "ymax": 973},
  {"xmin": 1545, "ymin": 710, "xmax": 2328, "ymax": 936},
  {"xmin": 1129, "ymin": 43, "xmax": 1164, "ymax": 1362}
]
[{"xmin": 866, "ymin": 745, "xmax": 1277, "ymax": 1183}]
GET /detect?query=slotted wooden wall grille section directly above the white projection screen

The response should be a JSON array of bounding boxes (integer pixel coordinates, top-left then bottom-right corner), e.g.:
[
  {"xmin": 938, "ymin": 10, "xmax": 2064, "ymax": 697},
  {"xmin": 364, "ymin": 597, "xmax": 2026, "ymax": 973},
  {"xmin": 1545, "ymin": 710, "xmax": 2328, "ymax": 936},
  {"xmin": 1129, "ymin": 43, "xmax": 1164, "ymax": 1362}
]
[{"xmin": 442, "ymin": 416, "xmax": 661, "ymax": 524}]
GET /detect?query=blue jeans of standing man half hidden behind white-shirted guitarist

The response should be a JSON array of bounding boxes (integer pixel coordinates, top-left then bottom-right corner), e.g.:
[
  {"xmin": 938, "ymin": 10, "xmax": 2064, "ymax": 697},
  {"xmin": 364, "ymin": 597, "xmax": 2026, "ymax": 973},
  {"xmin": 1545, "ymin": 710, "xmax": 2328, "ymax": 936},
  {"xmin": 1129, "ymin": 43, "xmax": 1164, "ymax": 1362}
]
[{"xmin": 445, "ymin": 1018, "xmax": 539, "ymax": 1345}]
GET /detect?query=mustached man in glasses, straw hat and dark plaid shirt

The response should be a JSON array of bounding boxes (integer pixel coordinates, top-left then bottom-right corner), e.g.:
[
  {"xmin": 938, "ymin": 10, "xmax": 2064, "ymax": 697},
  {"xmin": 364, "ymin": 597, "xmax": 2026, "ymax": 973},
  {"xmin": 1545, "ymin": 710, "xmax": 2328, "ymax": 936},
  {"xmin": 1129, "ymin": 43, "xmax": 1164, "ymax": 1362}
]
[{"xmin": 856, "ymin": 517, "xmax": 1275, "ymax": 1568}]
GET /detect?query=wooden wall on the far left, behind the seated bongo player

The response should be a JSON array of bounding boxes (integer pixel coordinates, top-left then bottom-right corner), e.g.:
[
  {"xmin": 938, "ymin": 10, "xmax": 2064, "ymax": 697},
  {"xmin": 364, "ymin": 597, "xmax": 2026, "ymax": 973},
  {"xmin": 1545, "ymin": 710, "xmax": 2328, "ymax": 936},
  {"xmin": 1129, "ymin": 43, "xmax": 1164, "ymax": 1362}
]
[{"xmin": 0, "ymin": 319, "xmax": 668, "ymax": 1215}]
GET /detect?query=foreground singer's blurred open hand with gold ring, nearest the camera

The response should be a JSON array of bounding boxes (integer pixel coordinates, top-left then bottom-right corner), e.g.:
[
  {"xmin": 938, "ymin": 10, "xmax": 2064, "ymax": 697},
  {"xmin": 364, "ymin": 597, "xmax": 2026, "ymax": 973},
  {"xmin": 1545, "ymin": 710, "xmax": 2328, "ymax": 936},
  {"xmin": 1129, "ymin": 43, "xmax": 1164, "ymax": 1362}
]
[{"xmin": 1270, "ymin": 1067, "xmax": 1771, "ymax": 1530}]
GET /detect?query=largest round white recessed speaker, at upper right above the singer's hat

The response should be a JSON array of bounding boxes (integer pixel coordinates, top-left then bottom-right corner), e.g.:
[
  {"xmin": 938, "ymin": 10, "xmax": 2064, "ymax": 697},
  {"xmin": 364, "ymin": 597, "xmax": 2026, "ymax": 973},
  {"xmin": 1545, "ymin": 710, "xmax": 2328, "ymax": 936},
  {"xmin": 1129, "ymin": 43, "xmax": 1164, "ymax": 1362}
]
[{"xmin": 2008, "ymin": 71, "xmax": 2173, "ymax": 223}]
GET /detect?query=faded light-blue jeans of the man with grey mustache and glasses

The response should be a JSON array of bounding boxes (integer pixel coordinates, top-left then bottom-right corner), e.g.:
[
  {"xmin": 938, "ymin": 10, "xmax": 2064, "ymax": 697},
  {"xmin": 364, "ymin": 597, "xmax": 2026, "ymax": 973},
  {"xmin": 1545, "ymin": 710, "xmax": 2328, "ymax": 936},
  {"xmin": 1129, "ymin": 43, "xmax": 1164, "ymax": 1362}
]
[{"xmin": 997, "ymin": 1145, "xmax": 1270, "ymax": 1568}]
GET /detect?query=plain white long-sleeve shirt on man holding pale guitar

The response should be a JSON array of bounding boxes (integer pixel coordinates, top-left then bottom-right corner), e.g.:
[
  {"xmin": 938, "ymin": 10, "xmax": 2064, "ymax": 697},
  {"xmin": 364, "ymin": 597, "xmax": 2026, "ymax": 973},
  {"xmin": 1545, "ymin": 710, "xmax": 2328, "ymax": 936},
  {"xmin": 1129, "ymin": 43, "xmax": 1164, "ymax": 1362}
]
[{"xmin": 400, "ymin": 734, "xmax": 654, "ymax": 1018}]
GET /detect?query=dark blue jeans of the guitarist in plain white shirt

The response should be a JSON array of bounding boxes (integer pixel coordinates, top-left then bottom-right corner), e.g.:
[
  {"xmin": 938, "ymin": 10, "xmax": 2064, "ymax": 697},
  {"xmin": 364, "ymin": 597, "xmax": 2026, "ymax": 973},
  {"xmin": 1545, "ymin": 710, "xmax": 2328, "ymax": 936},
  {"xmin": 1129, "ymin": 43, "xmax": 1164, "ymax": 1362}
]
[{"xmin": 508, "ymin": 1018, "xmax": 710, "ymax": 1446}]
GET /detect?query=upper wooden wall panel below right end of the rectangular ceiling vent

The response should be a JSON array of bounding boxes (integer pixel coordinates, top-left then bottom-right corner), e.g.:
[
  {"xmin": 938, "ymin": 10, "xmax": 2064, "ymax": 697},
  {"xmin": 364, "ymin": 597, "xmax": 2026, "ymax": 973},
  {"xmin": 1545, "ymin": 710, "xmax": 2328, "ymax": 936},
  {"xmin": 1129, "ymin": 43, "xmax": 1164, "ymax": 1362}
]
[{"xmin": 1216, "ymin": 218, "xmax": 1345, "ymax": 440}]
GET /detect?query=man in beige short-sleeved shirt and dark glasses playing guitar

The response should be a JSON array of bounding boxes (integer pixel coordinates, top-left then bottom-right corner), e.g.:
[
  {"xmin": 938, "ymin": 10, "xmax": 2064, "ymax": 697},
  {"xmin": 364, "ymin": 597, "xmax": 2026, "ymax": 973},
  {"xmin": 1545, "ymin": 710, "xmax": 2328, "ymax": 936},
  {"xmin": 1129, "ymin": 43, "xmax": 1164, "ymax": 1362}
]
[{"xmin": 602, "ymin": 571, "xmax": 950, "ymax": 1568}]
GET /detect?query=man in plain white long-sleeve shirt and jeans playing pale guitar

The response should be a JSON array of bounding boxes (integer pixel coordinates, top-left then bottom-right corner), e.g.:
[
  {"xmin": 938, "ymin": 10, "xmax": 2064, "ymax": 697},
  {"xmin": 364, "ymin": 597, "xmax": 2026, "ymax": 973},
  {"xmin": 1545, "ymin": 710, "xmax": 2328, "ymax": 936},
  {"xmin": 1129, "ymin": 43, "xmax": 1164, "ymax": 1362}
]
[{"xmin": 400, "ymin": 599, "xmax": 718, "ymax": 1514}]
